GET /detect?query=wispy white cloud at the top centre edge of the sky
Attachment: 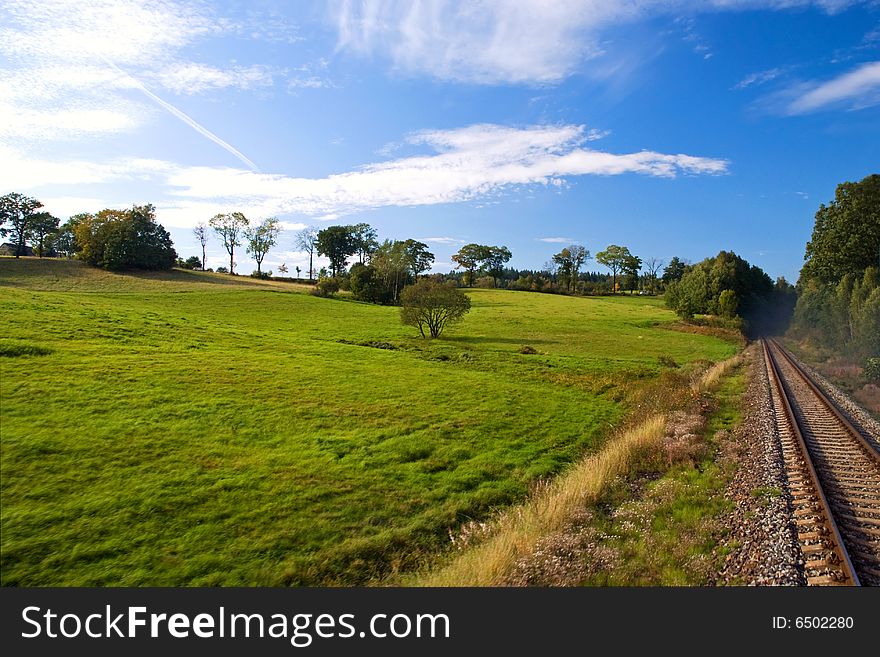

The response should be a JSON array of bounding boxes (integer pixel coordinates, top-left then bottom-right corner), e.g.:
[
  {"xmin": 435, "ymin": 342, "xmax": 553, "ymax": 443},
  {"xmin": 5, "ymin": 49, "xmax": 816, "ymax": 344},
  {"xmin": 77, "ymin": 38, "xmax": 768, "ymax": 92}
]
[{"xmin": 332, "ymin": 0, "xmax": 860, "ymax": 84}]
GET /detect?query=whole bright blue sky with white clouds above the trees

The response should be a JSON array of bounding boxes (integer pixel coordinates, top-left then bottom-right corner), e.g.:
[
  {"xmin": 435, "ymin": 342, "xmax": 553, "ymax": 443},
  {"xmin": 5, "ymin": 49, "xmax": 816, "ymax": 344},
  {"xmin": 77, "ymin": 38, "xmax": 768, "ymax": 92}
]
[{"xmin": 0, "ymin": 0, "xmax": 880, "ymax": 280}]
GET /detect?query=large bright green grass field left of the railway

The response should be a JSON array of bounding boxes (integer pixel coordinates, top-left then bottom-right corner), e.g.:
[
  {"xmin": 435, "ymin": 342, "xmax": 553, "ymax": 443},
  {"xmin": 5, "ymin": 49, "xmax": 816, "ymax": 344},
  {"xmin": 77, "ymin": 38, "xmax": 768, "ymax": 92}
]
[{"xmin": 0, "ymin": 258, "xmax": 737, "ymax": 586}]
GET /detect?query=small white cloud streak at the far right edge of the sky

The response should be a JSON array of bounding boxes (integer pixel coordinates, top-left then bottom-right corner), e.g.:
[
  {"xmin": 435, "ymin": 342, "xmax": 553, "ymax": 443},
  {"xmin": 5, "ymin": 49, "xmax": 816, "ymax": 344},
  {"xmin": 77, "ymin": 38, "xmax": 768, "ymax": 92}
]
[{"xmin": 786, "ymin": 62, "xmax": 880, "ymax": 114}]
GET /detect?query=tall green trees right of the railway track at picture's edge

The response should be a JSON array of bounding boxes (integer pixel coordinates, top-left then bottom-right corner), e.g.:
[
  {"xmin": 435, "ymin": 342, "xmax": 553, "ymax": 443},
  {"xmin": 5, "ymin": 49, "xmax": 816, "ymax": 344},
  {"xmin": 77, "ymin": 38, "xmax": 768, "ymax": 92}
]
[{"xmin": 792, "ymin": 174, "xmax": 880, "ymax": 359}]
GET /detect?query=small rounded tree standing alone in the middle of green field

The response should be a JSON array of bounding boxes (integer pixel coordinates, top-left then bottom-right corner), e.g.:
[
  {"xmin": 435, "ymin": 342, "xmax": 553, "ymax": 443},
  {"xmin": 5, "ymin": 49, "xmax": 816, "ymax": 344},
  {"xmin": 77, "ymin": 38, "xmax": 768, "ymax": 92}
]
[{"xmin": 400, "ymin": 278, "xmax": 471, "ymax": 338}]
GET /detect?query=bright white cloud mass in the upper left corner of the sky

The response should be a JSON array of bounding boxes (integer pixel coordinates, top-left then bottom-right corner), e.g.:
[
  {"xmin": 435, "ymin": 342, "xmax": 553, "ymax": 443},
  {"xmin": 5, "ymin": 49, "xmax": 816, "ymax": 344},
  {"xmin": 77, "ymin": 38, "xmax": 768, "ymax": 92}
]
[{"xmin": 0, "ymin": 0, "xmax": 289, "ymax": 149}]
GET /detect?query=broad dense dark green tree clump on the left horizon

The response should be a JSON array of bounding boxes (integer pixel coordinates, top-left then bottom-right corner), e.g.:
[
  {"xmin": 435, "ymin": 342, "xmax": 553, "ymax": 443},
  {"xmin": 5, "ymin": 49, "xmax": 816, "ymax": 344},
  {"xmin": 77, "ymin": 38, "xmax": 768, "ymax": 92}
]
[{"xmin": 74, "ymin": 205, "xmax": 177, "ymax": 271}]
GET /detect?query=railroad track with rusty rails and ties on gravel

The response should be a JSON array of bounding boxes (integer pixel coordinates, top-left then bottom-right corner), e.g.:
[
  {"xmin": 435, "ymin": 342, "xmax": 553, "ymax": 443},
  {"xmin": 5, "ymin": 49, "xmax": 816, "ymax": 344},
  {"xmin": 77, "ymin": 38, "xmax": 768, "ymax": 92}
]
[{"xmin": 763, "ymin": 340, "xmax": 880, "ymax": 586}]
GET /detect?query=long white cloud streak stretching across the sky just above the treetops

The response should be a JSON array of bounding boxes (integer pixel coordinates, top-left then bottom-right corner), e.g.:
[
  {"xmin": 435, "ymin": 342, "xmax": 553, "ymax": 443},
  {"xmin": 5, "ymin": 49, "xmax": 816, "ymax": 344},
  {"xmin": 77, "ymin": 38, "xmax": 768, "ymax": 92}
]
[{"xmin": 0, "ymin": 124, "xmax": 728, "ymax": 223}]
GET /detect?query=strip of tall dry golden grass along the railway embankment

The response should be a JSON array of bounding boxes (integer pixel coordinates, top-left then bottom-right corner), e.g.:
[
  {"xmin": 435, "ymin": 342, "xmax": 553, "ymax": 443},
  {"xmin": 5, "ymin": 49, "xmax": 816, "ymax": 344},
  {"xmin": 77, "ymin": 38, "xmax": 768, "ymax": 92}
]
[{"xmin": 405, "ymin": 355, "xmax": 741, "ymax": 586}]
